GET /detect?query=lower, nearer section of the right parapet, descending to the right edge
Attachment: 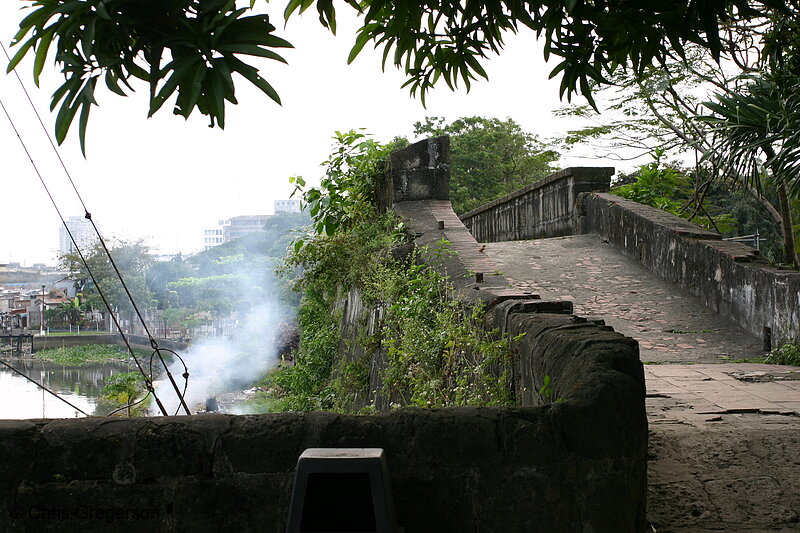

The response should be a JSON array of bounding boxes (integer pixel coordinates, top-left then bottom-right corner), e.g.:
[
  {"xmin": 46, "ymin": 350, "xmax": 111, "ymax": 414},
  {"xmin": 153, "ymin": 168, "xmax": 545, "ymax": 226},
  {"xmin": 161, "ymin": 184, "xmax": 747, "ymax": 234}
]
[{"xmin": 580, "ymin": 194, "xmax": 800, "ymax": 347}]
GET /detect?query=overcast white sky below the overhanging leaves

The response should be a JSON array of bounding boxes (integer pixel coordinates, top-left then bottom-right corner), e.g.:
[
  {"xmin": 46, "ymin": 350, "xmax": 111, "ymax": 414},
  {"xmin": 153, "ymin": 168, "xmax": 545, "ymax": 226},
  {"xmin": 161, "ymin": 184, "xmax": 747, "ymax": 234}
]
[{"xmin": 0, "ymin": 0, "xmax": 614, "ymax": 265}]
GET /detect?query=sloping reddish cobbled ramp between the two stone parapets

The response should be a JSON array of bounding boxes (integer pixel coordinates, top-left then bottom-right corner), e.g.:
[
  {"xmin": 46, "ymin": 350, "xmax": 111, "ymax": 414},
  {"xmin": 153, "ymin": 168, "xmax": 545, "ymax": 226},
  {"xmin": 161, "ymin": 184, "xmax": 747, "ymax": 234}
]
[{"xmin": 485, "ymin": 235, "xmax": 763, "ymax": 363}]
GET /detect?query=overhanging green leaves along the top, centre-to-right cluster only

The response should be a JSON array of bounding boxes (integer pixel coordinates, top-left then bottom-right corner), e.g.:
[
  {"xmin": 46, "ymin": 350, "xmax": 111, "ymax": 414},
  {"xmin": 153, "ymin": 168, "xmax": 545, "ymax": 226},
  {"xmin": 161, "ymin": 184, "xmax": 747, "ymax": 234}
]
[{"xmin": 284, "ymin": 0, "xmax": 786, "ymax": 106}]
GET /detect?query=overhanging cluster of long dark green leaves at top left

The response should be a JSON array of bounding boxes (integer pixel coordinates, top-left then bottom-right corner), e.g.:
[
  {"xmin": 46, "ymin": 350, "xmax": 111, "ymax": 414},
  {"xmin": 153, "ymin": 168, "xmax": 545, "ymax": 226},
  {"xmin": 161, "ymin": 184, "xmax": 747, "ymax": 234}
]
[{"xmin": 8, "ymin": 0, "xmax": 292, "ymax": 154}]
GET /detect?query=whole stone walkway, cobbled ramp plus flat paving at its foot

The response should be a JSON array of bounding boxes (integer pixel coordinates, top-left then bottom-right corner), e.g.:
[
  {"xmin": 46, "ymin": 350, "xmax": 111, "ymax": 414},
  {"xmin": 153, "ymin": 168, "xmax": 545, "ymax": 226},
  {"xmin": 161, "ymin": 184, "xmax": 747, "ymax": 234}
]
[{"xmin": 485, "ymin": 235, "xmax": 800, "ymax": 533}]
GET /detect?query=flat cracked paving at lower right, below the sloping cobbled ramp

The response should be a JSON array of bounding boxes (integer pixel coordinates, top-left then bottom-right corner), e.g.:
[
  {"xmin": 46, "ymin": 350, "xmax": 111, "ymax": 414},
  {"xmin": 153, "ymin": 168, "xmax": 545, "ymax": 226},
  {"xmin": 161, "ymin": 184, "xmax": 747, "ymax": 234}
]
[{"xmin": 645, "ymin": 363, "xmax": 800, "ymax": 533}]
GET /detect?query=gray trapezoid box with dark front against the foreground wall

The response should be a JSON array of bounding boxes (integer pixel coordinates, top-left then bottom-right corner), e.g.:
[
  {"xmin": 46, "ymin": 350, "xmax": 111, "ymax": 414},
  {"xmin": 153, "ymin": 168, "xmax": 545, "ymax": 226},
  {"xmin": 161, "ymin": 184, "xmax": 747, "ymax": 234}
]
[{"xmin": 286, "ymin": 448, "xmax": 397, "ymax": 533}]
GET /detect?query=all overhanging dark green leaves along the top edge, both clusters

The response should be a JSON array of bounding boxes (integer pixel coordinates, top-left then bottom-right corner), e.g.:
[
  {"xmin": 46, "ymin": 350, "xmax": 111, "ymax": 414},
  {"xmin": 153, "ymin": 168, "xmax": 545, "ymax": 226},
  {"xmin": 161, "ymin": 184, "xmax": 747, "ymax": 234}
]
[{"xmin": 9, "ymin": 0, "xmax": 796, "ymax": 154}]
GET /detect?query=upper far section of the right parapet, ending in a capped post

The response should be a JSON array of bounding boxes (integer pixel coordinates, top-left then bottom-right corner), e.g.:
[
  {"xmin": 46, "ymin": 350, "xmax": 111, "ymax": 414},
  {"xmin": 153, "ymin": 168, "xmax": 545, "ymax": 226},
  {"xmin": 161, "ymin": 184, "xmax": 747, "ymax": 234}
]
[{"xmin": 461, "ymin": 167, "xmax": 614, "ymax": 242}]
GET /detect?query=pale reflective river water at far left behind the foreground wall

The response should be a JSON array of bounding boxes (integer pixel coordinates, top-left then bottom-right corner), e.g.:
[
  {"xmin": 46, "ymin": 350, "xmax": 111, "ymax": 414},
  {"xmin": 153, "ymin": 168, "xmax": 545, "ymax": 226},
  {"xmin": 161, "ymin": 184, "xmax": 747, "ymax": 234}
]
[{"xmin": 0, "ymin": 359, "xmax": 133, "ymax": 419}]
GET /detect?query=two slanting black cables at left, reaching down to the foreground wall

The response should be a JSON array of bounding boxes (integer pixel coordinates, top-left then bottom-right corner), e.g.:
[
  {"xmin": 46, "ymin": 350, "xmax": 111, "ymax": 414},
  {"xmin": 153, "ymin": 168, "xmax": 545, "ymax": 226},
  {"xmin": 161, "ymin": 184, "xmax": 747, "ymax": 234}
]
[{"xmin": 0, "ymin": 42, "xmax": 190, "ymax": 416}]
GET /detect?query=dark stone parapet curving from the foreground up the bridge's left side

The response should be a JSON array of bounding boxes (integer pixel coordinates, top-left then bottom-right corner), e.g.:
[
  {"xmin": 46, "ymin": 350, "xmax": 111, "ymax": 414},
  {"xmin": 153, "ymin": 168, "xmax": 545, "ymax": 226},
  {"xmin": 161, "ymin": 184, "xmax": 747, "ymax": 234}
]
[{"xmin": 0, "ymin": 140, "xmax": 647, "ymax": 533}]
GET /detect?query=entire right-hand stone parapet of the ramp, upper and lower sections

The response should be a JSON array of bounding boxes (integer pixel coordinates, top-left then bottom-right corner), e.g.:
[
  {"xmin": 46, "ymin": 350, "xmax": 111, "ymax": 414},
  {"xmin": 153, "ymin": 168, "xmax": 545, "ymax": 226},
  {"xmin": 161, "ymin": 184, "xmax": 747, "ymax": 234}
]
[{"xmin": 461, "ymin": 158, "xmax": 800, "ymax": 347}]
